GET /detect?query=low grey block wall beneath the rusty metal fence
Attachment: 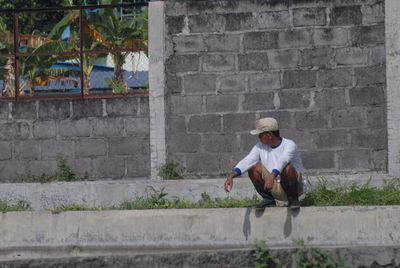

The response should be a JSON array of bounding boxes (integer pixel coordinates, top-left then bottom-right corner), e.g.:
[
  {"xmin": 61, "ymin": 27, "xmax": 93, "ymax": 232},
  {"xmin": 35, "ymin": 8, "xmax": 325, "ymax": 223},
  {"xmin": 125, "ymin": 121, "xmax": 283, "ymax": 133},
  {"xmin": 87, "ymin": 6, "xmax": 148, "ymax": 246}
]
[{"xmin": 0, "ymin": 96, "xmax": 150, "ymax": 182}]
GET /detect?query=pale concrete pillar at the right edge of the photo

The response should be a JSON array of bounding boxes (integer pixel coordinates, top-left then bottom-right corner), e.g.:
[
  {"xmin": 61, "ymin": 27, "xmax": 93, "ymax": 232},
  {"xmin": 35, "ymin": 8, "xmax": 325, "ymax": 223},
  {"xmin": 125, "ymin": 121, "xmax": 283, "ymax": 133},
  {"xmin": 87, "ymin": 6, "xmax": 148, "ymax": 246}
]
[{"xmin": 385, "ymin": 0, "xmax": 400, "ymax": 176}]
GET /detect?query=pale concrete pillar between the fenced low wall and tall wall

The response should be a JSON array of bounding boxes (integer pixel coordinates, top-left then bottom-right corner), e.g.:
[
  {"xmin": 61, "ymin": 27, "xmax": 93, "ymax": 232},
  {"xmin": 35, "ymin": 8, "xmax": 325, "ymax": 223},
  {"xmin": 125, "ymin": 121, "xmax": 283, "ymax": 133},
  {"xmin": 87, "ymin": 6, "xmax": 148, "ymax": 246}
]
[{"xmin": 149, "ymin": 1, "xmax": 166, "ymax": 179}]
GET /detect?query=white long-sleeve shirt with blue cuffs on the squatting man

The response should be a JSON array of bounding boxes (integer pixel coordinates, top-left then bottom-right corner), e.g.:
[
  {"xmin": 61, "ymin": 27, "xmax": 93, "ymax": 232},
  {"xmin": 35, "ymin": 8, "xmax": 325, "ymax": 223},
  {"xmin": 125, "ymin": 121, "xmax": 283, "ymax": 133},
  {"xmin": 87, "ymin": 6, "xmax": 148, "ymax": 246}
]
[{"xmin": 235, "ymin": 138, "xmax": 304, "ymax": 180}]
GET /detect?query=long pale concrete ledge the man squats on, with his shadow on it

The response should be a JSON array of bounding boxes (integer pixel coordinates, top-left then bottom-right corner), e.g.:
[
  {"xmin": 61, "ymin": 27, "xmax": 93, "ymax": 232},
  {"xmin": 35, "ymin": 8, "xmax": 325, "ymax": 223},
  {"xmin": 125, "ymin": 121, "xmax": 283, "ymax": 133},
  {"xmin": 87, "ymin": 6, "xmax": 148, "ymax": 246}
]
[{"xmin": 0, "ymin": 206, "xmax": 400, "ymax": 259}]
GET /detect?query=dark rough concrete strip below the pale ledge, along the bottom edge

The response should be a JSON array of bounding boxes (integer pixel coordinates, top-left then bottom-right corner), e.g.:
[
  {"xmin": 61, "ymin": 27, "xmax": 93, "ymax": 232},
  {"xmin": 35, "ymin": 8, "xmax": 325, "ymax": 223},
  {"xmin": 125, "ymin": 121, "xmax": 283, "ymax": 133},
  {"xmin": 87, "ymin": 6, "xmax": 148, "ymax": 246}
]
[{"xmin": 0, "ymin": 247, "xmax": 400, "ymax": 268}]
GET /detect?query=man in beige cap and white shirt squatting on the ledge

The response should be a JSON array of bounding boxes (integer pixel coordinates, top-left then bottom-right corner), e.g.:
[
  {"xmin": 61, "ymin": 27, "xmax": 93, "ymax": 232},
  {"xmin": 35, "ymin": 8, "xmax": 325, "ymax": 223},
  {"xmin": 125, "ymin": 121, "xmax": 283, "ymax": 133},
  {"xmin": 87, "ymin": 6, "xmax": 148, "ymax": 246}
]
[{"xmin": 224, "ymin": 117, "xmax": 305, "ymax": 210}]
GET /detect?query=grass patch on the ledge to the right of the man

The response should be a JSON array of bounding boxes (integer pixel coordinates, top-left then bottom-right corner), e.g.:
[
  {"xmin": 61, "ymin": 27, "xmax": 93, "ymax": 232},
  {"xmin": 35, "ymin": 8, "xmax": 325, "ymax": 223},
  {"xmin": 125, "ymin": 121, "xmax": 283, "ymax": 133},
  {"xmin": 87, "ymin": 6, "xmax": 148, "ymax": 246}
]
[{"xmin": 301, "ymin": 178, "xmax": 400, "ymax": 206}]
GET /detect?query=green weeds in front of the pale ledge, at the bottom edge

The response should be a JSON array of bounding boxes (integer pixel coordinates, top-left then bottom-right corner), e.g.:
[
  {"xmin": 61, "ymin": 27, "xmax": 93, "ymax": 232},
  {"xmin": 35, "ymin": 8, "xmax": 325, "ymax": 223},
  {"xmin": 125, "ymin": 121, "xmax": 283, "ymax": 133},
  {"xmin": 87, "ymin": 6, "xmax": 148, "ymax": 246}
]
[{"xmin": 252, "ymin": 238, "xmax": 351, "ymax": 268}]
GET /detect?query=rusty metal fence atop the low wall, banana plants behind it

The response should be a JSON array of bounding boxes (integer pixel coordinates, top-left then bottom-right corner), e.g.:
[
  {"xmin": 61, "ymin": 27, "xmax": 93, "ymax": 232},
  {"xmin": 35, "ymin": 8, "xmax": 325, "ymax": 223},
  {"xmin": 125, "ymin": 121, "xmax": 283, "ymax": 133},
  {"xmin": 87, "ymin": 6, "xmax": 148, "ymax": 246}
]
[{"xmin": 0, "ymin": 0, "xmax": 148, "ymax": 101}]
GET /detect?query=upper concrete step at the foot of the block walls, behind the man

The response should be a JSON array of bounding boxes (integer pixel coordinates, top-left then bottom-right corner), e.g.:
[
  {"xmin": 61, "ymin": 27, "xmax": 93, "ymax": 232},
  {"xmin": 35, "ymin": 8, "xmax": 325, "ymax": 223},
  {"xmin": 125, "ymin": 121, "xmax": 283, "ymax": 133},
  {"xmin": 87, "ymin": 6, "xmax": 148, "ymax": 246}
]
[{"xmin": 0, "ymin": 173, "xmax": 391, "ymax": 210}]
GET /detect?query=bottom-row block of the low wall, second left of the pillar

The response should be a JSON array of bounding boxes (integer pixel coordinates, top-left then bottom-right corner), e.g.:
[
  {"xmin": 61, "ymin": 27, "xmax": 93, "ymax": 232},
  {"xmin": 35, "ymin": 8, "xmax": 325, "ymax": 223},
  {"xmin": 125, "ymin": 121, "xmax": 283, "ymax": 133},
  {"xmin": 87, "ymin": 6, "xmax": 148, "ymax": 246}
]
[{"xmin": 93, "ymin": 157, "xmax": 125, "ymax": 180}]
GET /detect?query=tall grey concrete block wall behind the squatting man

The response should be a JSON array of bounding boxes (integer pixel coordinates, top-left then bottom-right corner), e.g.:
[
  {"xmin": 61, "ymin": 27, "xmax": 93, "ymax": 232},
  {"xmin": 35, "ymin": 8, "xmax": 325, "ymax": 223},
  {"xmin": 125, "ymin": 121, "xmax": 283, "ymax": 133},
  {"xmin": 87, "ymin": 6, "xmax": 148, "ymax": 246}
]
[{"xmin": 164, "ymin": 0, "xmax": 387, "ymax": 177}]
